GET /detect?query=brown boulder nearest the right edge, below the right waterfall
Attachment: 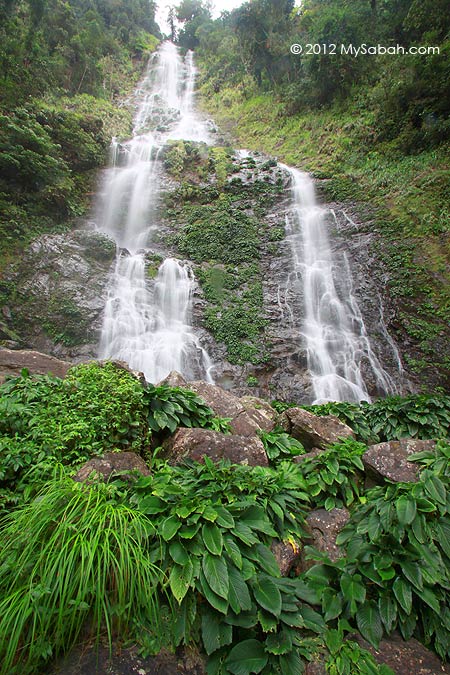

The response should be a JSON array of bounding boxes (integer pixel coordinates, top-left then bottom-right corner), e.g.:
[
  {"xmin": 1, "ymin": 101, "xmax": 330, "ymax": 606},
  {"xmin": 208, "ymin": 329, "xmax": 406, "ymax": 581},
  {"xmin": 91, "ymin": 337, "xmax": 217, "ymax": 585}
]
[{"xmin": 362, "ymin": 438, "xmax": 436, "ymax": 483}]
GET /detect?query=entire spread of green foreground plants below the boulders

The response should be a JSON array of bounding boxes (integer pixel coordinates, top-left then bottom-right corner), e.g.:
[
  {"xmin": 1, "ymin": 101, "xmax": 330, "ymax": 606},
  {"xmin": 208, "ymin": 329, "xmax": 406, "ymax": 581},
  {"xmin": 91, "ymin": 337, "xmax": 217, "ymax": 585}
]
[{"xmin": 0, "ymin": 363, "xmax": 450, "ymax": 675}]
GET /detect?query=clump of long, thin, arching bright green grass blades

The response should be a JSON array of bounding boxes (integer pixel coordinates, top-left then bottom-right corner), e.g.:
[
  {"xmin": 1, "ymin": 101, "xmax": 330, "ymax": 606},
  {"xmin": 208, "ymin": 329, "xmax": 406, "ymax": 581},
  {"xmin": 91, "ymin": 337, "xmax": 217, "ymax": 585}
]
[{"xmin": 0, "ymin": 475, "xmax": 165, "ymax": 675}]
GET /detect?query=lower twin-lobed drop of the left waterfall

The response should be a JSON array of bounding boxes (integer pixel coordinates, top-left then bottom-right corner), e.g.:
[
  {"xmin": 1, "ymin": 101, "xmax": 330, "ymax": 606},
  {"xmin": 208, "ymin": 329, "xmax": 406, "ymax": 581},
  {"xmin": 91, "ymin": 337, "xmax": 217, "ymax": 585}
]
[{"xmin": 100, "ymin": 253, "xmax": 213, "ymax": 382}]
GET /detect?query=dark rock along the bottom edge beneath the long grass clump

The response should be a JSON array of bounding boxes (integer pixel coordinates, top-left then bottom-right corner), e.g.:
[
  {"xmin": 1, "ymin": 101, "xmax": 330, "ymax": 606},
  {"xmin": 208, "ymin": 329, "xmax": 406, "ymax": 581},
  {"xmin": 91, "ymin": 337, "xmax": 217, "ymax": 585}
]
[{"xmin": 45, "ymin": 644, "xmax": 206, "ymax": 675}]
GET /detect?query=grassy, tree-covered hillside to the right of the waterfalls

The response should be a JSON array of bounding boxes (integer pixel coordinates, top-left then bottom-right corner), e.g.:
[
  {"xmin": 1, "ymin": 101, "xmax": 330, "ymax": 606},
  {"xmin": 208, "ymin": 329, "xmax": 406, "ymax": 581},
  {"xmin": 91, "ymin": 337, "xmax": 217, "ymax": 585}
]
[{"xmin": 188, "ymin": 0, "xmax": 450, "ymax": 385}]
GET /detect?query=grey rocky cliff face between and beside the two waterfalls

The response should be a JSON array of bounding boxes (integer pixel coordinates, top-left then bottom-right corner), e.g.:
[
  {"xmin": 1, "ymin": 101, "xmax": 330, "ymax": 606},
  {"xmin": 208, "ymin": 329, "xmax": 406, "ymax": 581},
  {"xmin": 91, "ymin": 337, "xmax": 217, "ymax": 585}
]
[{"xmin": 0, "ymin": 141, "xmax": 414, "ymax": 403}]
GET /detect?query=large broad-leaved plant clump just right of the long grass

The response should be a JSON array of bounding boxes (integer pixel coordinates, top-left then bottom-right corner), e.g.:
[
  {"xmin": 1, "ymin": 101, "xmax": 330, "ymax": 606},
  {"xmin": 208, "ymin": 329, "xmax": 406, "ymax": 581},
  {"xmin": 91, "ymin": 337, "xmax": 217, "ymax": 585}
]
[{"xmin": 133, "ymin": 458, "xmax": 324, "ymax": 675}]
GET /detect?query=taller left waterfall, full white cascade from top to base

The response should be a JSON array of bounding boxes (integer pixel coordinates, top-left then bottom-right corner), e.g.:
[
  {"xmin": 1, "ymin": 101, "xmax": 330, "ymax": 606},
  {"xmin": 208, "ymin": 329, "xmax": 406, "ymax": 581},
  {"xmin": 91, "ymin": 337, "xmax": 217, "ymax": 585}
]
[{"xmin": 97, "ymin": 43, "xmax": 213, "ymax": 382}]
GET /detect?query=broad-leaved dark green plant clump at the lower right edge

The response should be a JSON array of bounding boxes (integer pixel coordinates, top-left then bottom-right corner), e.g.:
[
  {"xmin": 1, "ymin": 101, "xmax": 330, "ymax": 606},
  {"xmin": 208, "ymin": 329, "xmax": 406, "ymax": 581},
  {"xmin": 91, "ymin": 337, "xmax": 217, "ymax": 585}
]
[{"xmin": 304, "ymin": 443, "xmax": 450, "ymax": 658}]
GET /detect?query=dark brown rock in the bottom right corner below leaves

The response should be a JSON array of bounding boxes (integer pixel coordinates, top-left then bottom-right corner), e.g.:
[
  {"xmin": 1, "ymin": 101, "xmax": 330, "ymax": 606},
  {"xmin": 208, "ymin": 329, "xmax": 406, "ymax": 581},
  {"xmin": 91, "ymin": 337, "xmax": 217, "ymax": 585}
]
[{"xmin": 351, "ymin": 634, "xmax": 450, "ymax": 675}]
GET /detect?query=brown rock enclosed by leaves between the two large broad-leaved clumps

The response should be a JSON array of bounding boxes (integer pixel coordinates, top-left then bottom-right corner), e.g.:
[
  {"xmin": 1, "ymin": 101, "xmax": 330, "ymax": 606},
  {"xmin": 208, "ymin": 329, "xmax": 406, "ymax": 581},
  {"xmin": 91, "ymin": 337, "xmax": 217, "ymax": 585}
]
[{"xmin": 300, "ymin": 509, "xmax": 350, "ymax": 572}]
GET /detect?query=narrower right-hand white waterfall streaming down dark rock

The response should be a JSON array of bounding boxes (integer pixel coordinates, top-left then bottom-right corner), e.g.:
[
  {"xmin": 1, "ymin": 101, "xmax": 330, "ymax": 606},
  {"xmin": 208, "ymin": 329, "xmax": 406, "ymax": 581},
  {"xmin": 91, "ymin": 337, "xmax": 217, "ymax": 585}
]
[{"xmin": 281, "ymin": 165, "xmax": 395, "ymax": 403}]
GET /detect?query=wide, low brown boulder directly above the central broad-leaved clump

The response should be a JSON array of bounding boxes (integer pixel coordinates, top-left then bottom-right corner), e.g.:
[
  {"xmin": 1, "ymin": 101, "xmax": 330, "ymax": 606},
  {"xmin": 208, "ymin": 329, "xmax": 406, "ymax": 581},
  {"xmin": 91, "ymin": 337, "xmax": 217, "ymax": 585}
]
[{"xmin": 164, "ymin": 427, "xmax": 269, "ymax": 466}]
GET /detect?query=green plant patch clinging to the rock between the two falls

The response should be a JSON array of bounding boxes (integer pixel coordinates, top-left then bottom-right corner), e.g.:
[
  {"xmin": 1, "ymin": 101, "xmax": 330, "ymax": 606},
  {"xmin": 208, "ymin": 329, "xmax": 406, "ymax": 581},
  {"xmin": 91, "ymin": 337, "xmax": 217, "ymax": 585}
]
[{"xmin": 164, "ymin": 141, "xmax": 284, "ymax": 365}]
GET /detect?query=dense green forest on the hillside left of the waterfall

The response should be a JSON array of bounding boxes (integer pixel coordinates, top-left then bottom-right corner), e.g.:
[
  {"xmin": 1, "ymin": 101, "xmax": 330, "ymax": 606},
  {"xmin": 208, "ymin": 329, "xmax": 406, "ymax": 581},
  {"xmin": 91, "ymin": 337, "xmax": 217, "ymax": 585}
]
[{"xmin": 0, "ymin": 0, "xmax": 159, "ymax": 257}]
